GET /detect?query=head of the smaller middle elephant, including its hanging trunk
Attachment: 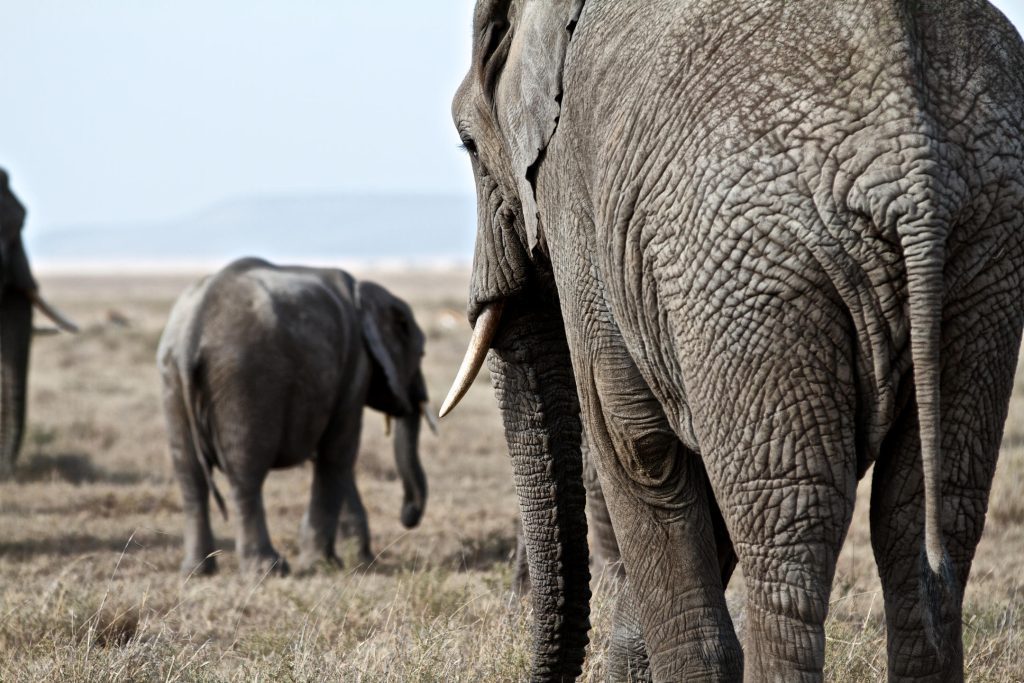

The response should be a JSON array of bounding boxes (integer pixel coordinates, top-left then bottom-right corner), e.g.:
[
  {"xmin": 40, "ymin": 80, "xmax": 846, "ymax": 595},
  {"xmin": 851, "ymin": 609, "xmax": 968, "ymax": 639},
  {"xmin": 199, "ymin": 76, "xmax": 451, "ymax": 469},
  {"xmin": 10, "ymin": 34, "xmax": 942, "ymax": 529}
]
[{"xmin": 355, "ymin": 282, "xmax": 433, "ymax": 528}]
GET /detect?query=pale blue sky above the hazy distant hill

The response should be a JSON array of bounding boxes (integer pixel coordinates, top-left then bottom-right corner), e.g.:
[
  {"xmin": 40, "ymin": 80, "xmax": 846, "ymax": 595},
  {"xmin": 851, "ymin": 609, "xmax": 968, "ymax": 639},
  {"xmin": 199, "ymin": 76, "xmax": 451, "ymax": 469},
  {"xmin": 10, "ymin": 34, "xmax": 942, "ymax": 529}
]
[{"xmin": 0, "ymin": 0, "xmax": 1024, "ymax": 240}]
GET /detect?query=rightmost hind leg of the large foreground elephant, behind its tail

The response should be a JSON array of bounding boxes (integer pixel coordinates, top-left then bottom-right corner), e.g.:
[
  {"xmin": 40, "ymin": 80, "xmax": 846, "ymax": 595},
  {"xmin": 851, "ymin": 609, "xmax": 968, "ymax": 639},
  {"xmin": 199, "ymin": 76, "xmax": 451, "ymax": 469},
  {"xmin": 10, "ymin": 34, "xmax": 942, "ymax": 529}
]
[{"xmin": 871, "ymin": 282, "xmax": 1021, "ymax": 681}]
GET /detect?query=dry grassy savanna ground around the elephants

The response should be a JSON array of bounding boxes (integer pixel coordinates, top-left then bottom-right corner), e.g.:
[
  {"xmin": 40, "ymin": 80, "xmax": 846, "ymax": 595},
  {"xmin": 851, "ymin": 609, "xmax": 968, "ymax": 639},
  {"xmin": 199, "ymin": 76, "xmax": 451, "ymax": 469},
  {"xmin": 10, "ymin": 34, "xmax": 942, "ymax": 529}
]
[{"xmin": 0, "ymin": 272, "xmax": 1024, "ymax": 681}]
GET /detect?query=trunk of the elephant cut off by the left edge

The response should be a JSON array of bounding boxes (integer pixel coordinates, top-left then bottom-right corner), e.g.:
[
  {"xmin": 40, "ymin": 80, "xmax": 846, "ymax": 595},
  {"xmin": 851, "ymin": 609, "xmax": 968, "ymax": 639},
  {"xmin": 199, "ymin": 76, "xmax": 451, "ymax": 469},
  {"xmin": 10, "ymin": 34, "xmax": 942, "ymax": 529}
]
[{"xmin": 0, "ymin": 287, "xmax": 32, "ymax": 479}]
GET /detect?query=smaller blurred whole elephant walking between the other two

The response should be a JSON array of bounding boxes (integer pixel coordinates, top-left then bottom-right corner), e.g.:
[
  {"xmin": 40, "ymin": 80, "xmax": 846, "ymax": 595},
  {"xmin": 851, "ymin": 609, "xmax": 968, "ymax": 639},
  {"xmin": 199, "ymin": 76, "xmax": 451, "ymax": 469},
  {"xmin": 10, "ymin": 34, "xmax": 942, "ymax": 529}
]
[{"xmin": 157, "ymin": 258, "xmax": 427, "ymax": 573}]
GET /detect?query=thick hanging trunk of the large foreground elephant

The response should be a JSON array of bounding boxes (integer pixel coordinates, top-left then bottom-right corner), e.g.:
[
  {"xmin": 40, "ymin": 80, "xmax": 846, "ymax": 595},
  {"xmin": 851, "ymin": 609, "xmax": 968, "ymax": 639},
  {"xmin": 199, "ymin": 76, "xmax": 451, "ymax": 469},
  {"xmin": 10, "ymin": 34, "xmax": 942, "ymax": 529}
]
[{"xmin": 488, "ymin": 306, "xmax": 590, "ymax": 681}]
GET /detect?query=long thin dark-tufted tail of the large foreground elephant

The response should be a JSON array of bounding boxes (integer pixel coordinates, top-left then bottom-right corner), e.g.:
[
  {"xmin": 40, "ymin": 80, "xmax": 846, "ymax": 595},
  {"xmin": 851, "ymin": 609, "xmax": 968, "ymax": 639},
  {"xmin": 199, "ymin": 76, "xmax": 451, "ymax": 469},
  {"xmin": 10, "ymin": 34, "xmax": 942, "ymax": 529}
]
[{"xmin": 897, "ymin": 220, "xmax": 957, "ymax": 653}]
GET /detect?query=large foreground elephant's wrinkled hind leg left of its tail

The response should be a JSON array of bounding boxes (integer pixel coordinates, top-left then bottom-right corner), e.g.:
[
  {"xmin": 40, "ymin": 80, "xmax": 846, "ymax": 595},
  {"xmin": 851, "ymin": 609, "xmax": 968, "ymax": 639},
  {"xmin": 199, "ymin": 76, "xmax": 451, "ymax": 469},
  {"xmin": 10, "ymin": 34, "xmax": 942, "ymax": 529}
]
[{"xmin": 687, "ymin": 299, "xmax": 858, "ymax": 681}]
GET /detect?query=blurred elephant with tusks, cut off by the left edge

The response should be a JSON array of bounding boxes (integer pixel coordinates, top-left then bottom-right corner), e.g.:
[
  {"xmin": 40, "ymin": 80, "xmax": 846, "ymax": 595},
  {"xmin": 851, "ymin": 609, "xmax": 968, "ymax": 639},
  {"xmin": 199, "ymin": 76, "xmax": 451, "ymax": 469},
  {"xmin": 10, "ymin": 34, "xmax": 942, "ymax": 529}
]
[{"xmin": 0, "ymin": 169, "xmax": 78, "ymax": 480}]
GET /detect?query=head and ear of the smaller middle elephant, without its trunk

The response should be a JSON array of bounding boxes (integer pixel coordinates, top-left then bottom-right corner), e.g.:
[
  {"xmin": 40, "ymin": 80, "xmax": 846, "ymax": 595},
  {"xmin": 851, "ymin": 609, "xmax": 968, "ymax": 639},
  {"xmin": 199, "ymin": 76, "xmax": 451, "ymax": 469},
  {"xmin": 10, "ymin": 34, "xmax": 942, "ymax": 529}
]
[{"xmin": 355, "ymin": 282, "xmax": 425, "ymax": 416}]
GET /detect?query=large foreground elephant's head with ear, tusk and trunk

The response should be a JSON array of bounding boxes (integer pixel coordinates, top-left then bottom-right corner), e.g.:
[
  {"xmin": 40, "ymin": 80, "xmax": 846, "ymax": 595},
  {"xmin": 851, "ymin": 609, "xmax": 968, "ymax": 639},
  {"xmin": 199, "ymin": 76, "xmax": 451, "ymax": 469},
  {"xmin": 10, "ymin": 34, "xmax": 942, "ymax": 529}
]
[{"xmin": 441, "ymin": 0, "xmax": 590, "ymax": 679}]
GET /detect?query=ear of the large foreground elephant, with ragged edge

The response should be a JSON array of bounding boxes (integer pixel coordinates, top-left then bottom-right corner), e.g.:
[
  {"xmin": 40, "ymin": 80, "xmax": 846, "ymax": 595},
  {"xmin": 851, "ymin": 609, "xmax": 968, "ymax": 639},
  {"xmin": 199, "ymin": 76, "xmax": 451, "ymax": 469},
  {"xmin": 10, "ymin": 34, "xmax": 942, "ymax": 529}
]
[{"xmin": 476, "ymin": 0, "xmax": 584, "ymax": 252}]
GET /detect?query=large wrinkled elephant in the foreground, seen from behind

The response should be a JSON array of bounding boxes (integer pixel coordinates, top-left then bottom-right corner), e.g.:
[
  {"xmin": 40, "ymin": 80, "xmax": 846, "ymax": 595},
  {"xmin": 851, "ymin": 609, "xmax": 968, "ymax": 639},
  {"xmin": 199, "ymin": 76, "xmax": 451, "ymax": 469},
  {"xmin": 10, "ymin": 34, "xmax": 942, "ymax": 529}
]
[{"xmin": 441, "ymin": 0, "xmax": 1024, "ymax": 681}]
